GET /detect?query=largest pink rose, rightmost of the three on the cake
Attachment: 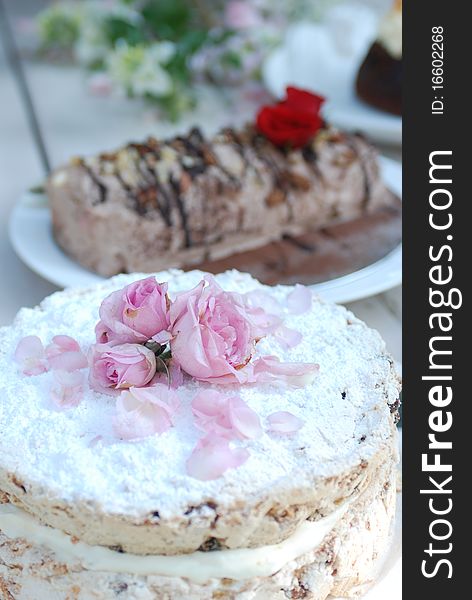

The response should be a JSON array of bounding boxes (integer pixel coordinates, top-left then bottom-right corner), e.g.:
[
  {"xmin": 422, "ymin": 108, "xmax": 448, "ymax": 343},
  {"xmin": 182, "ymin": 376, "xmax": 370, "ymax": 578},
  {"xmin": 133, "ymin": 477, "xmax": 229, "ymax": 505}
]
[{"xmin": 170, "ymin": 277, "xmax": 256, "ymax": 382}]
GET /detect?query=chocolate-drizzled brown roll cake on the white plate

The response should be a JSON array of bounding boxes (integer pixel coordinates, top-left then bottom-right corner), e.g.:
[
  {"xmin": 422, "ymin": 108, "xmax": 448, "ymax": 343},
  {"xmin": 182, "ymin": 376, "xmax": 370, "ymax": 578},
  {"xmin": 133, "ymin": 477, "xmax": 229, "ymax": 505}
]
[{"xmin": 47, "ymin": 126, "xmax": 393, "ymax": 276}]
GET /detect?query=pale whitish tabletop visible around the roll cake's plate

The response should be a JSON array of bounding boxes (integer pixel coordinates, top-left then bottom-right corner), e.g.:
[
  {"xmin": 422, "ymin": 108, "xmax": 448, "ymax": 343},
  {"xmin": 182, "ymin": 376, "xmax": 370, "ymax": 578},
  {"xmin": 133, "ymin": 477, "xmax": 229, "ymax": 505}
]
[{"xmin": 0, "ymin": 23, "xmax": 401, "ymax": 363}]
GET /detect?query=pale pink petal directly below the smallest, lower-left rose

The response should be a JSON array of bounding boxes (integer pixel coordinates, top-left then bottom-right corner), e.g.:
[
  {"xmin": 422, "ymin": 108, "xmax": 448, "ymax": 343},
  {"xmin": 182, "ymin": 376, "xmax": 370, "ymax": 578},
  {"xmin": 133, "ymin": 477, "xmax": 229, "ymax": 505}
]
[{"xmin": 113, "ymin": 384, "xmax": 180, "ymax": 440}]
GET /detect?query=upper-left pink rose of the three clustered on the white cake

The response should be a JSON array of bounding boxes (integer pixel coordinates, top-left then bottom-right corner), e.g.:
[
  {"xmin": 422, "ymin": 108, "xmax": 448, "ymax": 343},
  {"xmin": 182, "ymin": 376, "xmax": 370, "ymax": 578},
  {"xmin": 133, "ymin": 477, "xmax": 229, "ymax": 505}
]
[{"xmin": 95, "ymin": 277, "xmax": 170, "ymax": 344}]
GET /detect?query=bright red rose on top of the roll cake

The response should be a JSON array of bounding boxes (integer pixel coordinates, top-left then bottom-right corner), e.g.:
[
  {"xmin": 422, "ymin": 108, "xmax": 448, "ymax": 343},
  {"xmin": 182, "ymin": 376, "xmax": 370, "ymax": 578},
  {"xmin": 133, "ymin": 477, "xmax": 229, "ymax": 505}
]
[{"xmin": 257, "ymin": 87, "xmax": 324, "ymax": 148}]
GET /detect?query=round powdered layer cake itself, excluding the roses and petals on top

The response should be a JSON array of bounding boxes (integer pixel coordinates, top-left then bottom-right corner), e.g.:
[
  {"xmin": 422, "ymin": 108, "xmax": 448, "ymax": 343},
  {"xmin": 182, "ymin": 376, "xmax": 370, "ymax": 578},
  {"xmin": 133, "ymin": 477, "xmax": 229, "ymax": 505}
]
[{"xmin": 0, "ymin": 270, "xmax": 399, "ymax": 600}]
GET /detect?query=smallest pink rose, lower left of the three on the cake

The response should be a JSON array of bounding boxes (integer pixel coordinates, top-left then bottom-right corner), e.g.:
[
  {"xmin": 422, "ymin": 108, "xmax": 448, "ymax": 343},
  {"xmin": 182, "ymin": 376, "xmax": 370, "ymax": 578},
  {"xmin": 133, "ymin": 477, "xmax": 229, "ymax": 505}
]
[{"xmin": 89, "ymin": 344, "xmax": 156, "ymax": 394}]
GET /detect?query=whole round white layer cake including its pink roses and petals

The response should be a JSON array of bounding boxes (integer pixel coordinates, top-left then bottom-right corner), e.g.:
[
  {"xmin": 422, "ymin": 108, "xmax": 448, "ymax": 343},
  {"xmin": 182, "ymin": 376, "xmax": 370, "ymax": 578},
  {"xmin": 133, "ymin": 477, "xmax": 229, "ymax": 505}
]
[{"xmin": 0, "ymin": 270, "xmax": 399, "ymax": 600}]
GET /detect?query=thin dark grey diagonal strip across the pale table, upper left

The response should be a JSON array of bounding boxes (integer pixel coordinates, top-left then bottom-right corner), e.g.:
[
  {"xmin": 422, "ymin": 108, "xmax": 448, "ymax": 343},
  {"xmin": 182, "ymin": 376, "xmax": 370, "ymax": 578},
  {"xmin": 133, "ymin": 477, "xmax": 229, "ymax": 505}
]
[{"xmin": 0, "ymin": 0, "xmax": 51, "ymax": 175}]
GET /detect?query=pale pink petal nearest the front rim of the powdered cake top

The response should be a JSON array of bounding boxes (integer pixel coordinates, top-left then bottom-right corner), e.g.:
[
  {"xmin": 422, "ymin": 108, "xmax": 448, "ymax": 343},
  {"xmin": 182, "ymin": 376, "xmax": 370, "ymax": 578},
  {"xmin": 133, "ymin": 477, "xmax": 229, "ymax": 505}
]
[{"xmin": 186, "ymin": 434, "xmax": 249, "ymax": 481}]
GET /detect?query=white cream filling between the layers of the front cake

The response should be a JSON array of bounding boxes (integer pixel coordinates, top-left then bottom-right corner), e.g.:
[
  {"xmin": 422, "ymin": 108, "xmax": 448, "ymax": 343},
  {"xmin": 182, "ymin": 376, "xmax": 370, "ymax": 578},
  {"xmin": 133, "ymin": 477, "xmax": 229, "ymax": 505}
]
[{"xmin": 0, "ymin": 500, "xmax": 351, "ymax": 583}]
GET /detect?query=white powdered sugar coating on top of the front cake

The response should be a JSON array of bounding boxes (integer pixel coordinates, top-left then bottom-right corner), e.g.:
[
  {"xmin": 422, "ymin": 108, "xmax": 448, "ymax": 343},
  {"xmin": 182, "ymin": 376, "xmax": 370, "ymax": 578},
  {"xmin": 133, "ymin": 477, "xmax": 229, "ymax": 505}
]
[{"xmin": 0, "ymin": 271, "xmax": 398, "ymax": 517}]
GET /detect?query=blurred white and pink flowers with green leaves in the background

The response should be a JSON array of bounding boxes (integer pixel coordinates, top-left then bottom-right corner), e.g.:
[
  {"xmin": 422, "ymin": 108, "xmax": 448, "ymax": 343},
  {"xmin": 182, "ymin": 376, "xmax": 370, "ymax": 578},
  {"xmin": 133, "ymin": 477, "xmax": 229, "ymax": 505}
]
[{"xmin": 39, "ymin": 0, "xmax": 336, "ymax": 119}]
